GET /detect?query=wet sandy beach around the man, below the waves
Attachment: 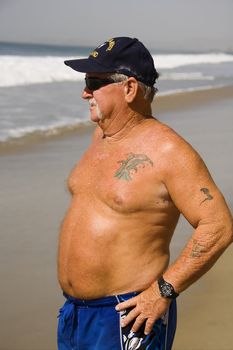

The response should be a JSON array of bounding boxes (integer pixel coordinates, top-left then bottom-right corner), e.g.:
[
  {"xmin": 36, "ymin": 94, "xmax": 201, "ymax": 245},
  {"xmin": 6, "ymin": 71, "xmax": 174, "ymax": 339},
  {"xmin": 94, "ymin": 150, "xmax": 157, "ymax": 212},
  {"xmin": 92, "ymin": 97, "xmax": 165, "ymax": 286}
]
[{"xmin": 0, "ymin": 87, "xmax": 233, "ymax": 350}]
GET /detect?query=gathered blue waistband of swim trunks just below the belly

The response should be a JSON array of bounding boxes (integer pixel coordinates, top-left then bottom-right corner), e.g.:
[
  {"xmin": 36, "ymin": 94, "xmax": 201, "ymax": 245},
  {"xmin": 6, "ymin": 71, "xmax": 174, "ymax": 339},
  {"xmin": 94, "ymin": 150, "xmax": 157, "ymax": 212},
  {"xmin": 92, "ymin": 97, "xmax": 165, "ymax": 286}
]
[{"xmin": 63, "ymin": 292, "xmax": 140, "ymax": 306}]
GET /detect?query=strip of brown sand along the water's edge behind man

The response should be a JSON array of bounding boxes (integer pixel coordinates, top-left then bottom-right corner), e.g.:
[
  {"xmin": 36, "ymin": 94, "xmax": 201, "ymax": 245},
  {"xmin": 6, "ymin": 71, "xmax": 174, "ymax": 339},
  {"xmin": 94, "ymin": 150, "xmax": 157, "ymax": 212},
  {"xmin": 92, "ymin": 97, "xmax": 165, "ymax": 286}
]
[{"xmin": 0, "ymin": 85, "xmax": 233, "ymax": 156}]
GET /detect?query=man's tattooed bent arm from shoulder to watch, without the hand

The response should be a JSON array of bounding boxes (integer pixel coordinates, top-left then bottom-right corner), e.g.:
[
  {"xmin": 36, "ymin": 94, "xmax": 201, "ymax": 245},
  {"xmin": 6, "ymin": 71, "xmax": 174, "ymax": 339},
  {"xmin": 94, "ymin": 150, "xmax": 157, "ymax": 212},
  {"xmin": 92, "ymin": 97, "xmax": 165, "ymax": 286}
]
[{"xmin": 163, "ymin": 145, "xmax": 233, "ymax": 293}]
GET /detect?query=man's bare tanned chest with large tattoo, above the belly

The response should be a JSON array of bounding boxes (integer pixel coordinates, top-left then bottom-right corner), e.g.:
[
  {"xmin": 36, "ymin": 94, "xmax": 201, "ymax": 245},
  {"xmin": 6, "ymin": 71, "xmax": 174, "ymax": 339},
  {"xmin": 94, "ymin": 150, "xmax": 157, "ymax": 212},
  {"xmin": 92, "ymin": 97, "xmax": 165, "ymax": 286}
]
[{"xmin": 68, "ymin": 147, "xmax": 170, "ymax": 213}]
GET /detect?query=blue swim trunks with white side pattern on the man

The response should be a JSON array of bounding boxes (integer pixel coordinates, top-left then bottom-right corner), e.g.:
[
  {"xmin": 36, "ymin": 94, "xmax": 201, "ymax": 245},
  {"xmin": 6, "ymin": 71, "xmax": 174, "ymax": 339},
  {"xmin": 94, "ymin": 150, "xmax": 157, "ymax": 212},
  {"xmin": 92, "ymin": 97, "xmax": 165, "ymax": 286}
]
[{"xmin": 58, "ymin": 292, "xmax": 176, "ymax": 350}]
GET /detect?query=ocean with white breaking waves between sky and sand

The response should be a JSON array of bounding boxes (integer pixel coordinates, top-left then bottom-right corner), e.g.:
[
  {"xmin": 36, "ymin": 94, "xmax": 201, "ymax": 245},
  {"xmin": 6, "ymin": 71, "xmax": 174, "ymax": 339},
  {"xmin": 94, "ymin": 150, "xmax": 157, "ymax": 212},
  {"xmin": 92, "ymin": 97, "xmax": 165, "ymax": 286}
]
[{"xmin": 0, "ymin": 43, "xmax": 233, "ymax": 143}]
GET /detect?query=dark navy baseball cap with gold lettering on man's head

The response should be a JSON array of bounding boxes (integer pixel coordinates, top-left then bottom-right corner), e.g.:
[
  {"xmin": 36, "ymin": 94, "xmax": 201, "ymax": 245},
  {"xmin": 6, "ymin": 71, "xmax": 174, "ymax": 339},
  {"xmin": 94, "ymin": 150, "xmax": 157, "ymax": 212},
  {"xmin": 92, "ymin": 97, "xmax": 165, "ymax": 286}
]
[{"xmin": 65, "ymin": 37, "xmax": 158, "ymax": 86}]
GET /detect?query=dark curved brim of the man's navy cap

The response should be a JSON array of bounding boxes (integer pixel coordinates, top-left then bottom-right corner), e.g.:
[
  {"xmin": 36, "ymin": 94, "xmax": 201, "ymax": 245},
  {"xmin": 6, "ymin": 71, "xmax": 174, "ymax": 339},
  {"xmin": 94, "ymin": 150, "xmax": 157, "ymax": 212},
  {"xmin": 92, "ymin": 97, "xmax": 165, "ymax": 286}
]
[{"xmin": 64, "ymin": 58, "xmax": 114, "ymax": 73}]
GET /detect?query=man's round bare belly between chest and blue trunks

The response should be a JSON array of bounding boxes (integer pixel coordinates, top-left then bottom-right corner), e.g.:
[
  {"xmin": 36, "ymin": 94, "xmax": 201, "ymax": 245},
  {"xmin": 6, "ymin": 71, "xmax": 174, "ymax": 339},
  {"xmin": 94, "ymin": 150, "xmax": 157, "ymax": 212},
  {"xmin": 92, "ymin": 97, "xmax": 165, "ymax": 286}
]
[{"xmin": 58, "ymin": 198, "xmax": 174, "ymax": 299}]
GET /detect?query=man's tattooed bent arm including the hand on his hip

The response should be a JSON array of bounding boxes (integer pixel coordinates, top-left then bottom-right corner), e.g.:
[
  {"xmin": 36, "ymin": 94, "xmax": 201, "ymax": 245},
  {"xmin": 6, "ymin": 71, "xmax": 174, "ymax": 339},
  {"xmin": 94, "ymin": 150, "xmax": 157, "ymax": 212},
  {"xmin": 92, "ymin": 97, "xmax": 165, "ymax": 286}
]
[{"xmin": 117, "ymin": 140, "xmax": 233, "ymax": 334}]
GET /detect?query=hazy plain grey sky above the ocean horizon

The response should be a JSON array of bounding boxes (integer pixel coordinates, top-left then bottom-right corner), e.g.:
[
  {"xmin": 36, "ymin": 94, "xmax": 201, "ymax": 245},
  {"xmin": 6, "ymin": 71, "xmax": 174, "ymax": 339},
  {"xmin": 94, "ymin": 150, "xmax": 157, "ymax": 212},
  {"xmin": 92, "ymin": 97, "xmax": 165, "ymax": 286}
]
[{"xmin": 0, "ymin": 0, "xmax": 233, "ymax": 52}]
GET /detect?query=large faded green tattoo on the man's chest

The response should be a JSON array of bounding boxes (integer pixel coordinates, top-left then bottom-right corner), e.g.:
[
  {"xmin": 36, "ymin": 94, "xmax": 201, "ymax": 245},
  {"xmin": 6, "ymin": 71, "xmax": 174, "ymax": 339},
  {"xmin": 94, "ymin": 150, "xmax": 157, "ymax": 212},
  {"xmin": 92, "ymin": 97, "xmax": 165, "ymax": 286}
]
[{"xmin": 114, "ymin": 153, "xmax": 154, "ymax": 181}]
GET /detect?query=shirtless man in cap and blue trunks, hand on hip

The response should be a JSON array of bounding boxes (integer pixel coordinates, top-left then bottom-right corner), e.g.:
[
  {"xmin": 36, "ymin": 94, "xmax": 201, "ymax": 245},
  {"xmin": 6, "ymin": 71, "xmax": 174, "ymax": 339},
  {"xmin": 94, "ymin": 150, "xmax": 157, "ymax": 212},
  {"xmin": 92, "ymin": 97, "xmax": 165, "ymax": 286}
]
[{"xmin": 58, "ymin": 37, "xmax": 233, "ymax": 350}]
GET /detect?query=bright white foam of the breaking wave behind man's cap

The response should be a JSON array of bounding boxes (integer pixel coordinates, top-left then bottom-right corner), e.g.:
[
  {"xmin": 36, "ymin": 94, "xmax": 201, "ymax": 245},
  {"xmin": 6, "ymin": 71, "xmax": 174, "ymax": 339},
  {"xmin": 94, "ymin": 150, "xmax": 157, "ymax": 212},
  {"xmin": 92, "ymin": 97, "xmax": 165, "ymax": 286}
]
[{"xmin": 0, "ymin": 53, "xmax": 233, "ymax": 87}]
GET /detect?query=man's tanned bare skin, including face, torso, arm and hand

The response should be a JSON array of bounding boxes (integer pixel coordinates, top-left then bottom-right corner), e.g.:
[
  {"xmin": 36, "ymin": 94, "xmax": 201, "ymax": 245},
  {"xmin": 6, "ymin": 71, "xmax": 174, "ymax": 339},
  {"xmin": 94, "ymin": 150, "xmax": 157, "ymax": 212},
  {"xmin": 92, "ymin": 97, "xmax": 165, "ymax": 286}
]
[{"xmin": 58, "ymin": 74, "xmax": 233, "ymax": 334}]
